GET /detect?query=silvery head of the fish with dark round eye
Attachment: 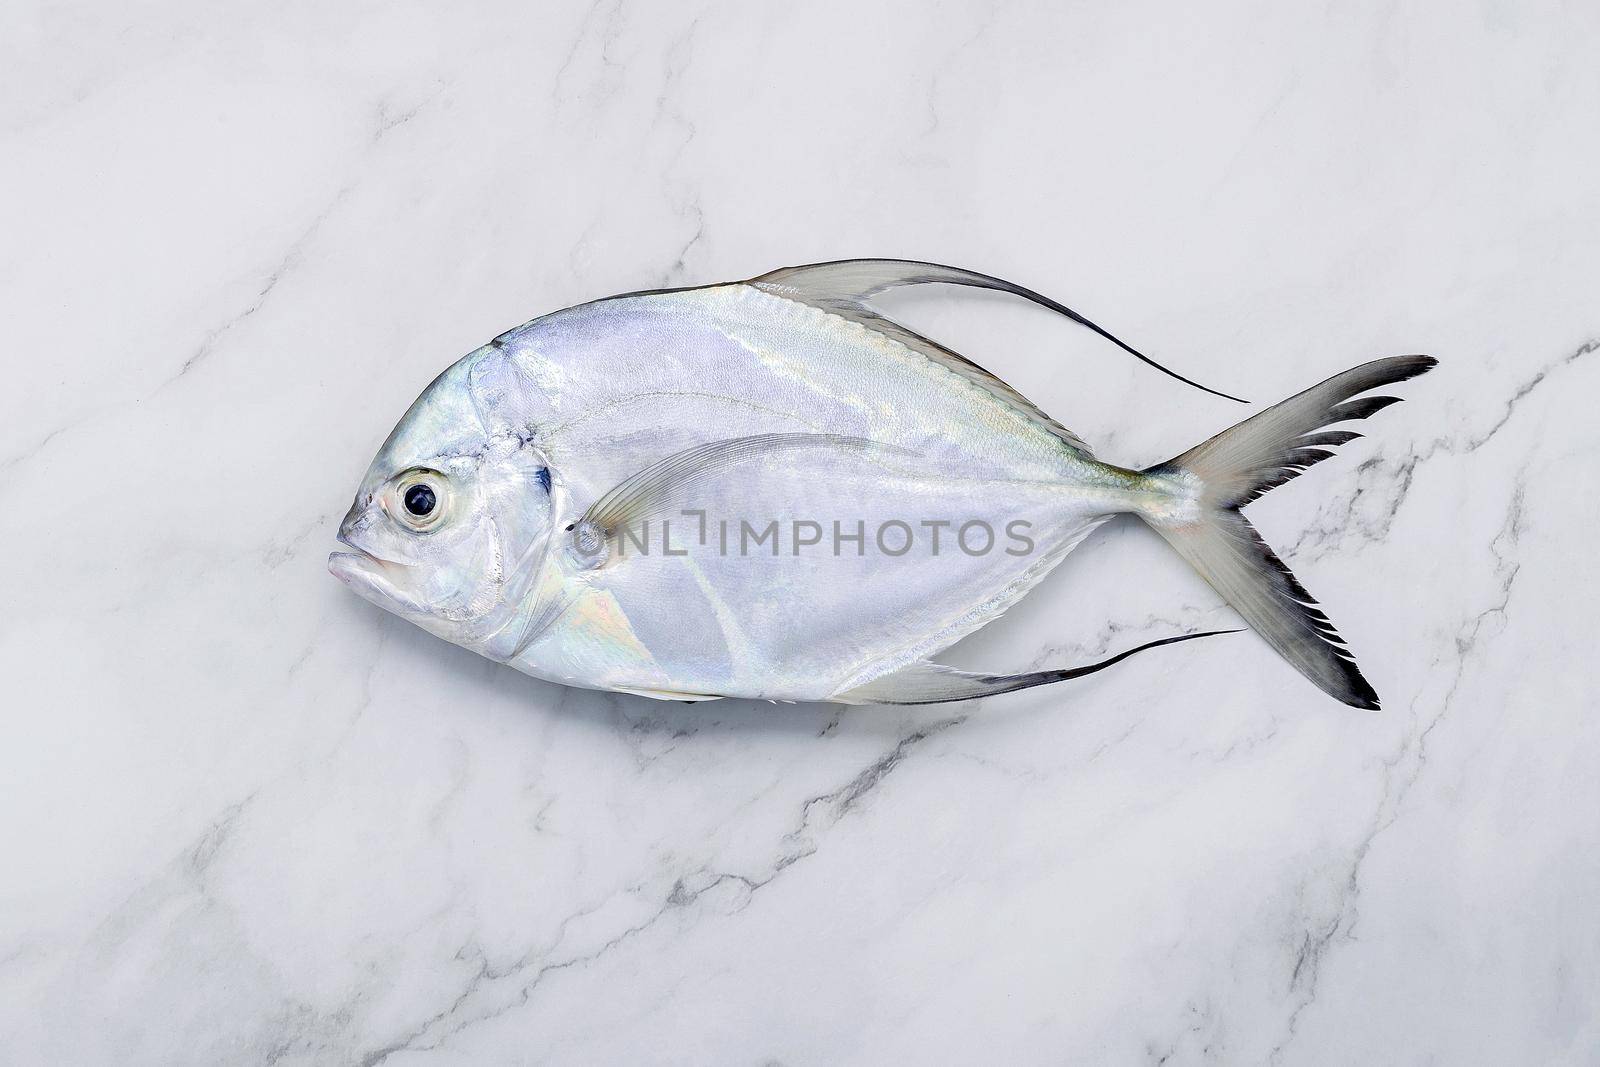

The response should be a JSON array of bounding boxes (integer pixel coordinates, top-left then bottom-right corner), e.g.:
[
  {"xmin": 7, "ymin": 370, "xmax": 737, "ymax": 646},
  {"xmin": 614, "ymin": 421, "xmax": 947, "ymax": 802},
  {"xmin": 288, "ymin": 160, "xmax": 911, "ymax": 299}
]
[{"xmin": 328, "ymin": 346, "xmax": 554, "ymax": 659}]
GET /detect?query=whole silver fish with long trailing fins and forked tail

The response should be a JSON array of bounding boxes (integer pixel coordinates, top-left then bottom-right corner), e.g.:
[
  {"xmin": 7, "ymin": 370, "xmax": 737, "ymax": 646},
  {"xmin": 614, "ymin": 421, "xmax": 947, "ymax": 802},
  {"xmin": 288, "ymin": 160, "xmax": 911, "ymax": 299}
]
[{"xmin": 328, "ymin": 259, "xmax": 1435, "ymax": 710}]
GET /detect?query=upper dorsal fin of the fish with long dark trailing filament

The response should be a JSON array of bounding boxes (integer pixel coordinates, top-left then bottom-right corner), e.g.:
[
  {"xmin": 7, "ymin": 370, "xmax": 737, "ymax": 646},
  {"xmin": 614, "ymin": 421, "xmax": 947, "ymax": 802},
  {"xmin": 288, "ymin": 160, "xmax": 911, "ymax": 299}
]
[{"xmin": 749, "ymin": 259, "xmax": 1248, "ymax": 453}]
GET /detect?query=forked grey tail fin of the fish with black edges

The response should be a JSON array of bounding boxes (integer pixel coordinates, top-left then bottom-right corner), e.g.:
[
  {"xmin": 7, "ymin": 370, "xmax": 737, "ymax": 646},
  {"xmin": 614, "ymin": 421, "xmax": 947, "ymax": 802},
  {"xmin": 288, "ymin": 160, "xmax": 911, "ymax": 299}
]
[{"xmin": 1139, "ymin": 355, "xmax": 1437, "ymax": 710}]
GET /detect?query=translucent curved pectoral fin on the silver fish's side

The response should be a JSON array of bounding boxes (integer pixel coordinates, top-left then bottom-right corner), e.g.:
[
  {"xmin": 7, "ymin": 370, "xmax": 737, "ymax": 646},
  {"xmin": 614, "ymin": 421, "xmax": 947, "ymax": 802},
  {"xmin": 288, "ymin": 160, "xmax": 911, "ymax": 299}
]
[{"xmin": 574, "ymin": 434, "xmax": 910, "ymax": 537}]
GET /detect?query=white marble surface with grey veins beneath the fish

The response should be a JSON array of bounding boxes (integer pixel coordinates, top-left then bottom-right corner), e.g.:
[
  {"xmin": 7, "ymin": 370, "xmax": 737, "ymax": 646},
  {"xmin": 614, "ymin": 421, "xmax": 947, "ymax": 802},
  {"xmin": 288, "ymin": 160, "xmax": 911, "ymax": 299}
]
[{"xmin": 0, "ymin": 0, "xmax": 1600, "ymax": 1067}]
